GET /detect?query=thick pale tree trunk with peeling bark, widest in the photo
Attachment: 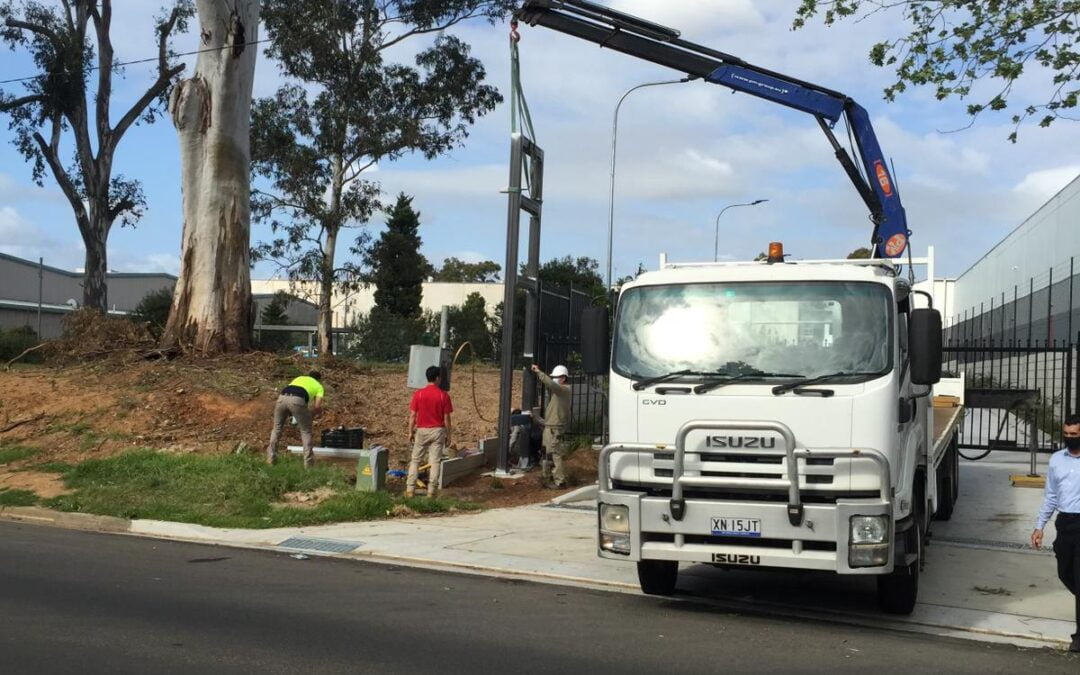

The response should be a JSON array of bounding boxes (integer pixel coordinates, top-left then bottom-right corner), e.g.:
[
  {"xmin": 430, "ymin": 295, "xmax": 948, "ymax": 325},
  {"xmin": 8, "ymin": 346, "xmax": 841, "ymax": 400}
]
[{"xmin": 162, "ymin": 0, "xmax": 259, "ymax": 354}]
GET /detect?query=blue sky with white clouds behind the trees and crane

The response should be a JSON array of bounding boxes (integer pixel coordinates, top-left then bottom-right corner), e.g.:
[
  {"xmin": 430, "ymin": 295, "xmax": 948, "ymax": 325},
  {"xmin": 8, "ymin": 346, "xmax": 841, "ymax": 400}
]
[{"xmin": 0, "ymin": 0, "xmax": 1080, "ymax": 285}]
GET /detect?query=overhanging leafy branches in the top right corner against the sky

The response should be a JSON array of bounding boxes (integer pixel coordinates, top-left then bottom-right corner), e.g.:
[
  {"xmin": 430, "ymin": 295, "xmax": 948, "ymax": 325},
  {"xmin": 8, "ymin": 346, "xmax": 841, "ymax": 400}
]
[{"xmin": 795, "ymin": 0, "xmax": 1080, "ymax": 141}]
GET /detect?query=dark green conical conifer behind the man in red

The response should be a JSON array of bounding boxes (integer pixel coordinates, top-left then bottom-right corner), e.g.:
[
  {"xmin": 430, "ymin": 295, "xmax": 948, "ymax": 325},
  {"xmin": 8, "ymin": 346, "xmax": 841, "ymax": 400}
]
[{"xmin": 366, "ymin": 194, "xmax": 431, "ymax": 319}]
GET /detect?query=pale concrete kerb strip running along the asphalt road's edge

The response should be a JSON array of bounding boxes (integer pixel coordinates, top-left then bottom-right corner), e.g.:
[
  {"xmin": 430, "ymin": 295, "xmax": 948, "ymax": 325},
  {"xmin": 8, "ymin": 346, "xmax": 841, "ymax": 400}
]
[{"xmin": 0, "ymin": 507, "xmax": 1068, "ymax": 649}]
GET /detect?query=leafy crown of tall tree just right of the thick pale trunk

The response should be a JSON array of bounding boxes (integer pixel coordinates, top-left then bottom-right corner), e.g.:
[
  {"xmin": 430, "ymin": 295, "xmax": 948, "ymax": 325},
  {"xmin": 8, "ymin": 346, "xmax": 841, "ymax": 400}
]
[{"xmin": 252, "ymin": 0, "xmax": 514, "ymax": 330}]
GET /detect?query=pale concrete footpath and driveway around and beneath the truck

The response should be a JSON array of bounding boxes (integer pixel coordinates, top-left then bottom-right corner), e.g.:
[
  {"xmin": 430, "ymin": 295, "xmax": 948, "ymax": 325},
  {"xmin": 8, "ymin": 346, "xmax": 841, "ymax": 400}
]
[{"xmin": 0, "ymin": 453, "xmax": 1074, "ymax": 648}]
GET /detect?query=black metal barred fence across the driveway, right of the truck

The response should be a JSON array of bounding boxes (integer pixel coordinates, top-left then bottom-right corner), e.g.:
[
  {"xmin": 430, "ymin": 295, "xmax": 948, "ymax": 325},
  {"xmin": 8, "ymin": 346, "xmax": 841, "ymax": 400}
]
[{"xmin": 943, "ymin": 336, "xmax": 1080, "ymax": 451}]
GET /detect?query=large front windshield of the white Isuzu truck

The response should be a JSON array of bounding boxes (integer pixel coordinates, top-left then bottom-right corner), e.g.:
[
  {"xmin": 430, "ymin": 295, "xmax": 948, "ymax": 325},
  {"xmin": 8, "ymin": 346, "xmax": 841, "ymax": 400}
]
[{"xmin": 613, "ymin": 282, "xmax": 892, "ymax": 379}]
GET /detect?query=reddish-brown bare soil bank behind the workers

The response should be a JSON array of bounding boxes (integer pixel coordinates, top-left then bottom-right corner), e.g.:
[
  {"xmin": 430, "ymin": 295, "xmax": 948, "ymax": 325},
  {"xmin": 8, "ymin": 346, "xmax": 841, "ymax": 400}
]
[{"xmin": 0, "ymin": 353, "xmax": 596, "ymax": 505}]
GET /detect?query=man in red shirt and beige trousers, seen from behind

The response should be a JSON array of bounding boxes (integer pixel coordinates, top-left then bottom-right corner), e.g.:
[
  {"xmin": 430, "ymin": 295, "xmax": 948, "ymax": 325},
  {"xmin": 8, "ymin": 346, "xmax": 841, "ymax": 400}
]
[{"xmin": 405, "ymin": 366, "xmax": 454, "ymax": 497}]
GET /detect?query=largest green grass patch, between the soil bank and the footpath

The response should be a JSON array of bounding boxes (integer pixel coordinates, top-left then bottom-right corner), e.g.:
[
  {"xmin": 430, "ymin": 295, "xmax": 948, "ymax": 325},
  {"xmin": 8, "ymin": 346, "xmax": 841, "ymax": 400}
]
[{"xmin": 46, "ymin": 450, "xmax": 476, "ymax": 528}]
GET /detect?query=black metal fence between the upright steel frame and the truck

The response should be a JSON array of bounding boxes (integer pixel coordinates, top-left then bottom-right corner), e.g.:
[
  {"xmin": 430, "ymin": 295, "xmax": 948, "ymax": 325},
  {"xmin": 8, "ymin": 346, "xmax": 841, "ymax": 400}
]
[{"xmin": 537, "ymin": 284, "xmax": 606, "ymax": 443}]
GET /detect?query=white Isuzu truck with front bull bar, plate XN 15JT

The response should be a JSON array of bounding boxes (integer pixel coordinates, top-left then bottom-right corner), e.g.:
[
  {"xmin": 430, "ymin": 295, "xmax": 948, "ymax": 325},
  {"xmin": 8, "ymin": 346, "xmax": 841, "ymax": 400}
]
[{"xmin": 582, "ymin": 244, "xmax": 961, "ymax": 613}]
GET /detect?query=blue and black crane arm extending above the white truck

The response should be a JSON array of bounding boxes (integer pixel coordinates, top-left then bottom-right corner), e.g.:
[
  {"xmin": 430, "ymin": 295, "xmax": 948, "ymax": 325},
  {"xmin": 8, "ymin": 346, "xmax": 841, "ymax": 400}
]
[{"xmin": 515, "ymin": 0, "xmax": 912, "ymax": 258}]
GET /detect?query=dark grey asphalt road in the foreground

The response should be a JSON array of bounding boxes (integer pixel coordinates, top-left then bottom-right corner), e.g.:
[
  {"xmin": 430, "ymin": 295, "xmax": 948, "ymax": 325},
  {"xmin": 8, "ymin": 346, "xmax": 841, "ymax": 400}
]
[{"xmin": 0, "ymin": 523, "xmax": 1080, "ymax": 675}]
